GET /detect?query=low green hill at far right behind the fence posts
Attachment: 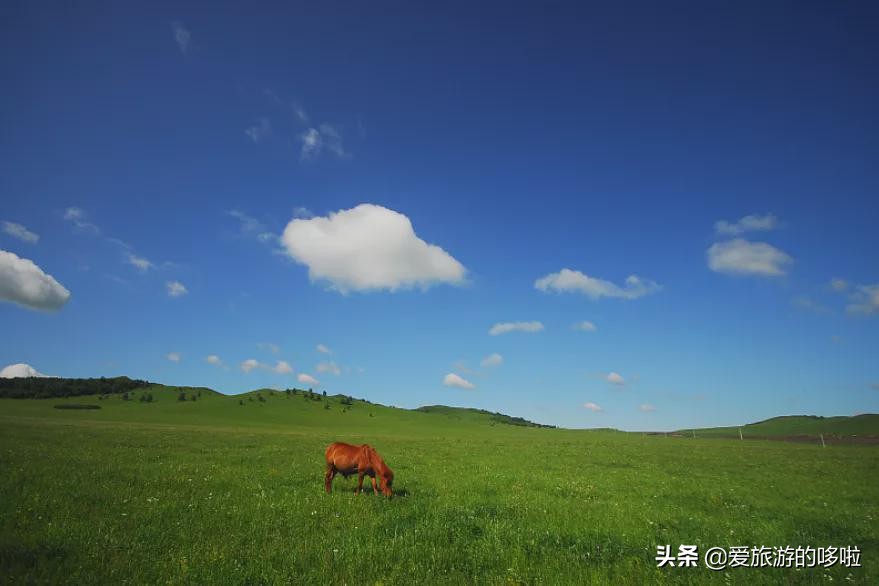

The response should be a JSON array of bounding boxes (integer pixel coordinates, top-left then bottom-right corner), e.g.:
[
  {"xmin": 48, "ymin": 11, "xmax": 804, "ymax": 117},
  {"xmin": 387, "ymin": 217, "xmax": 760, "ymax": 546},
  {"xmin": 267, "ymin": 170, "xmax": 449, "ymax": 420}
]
[{"xmin": 676, "ymin": 413, "xmax": 879, "ymax": 439}]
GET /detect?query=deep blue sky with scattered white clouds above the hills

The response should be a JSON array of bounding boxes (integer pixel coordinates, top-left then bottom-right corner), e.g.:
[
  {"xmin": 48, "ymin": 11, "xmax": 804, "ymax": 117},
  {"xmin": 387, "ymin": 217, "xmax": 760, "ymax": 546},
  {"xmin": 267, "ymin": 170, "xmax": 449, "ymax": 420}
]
[{"xmin": 0, "ymin": 2, "xmax": 879, "ymax": 429}]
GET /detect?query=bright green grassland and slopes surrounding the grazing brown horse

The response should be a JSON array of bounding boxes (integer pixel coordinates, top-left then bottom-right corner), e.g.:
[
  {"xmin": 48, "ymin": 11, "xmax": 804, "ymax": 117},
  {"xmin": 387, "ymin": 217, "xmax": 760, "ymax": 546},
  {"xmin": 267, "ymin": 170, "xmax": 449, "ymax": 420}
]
[{"xmin": 0, "ymin": 386, "xmax": 879, "ymax": 584}]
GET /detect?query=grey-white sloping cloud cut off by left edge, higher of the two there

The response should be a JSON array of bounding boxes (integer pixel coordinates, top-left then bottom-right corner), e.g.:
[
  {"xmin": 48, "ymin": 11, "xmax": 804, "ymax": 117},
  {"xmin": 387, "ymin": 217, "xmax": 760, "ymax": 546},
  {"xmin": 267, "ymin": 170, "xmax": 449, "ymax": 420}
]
[{"xmin": 0, "ymin": 250, "xmax": 70, "ymax": 311}]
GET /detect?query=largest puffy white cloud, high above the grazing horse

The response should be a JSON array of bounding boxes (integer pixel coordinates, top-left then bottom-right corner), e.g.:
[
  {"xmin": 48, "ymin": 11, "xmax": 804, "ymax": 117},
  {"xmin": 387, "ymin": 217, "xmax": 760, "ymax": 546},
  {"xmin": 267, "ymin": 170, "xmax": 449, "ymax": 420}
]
[{"xmin": 282, "ymin": 204, "xmax": 467, "ymax": 293}]
